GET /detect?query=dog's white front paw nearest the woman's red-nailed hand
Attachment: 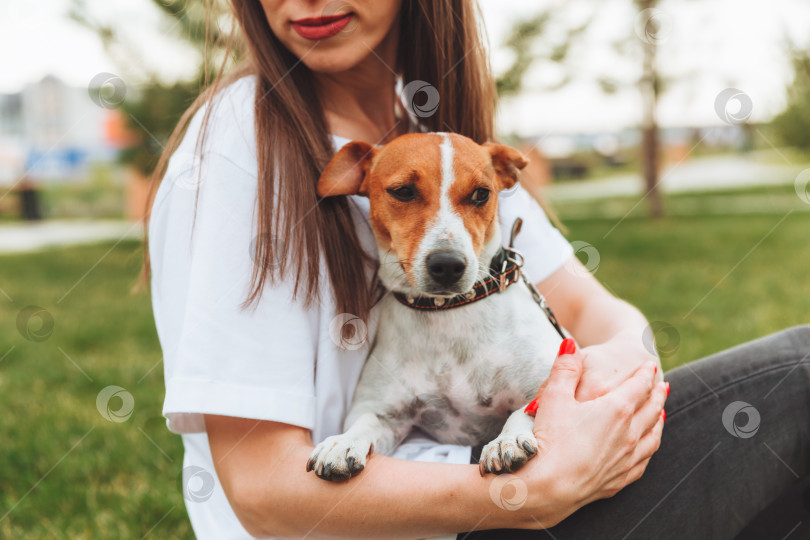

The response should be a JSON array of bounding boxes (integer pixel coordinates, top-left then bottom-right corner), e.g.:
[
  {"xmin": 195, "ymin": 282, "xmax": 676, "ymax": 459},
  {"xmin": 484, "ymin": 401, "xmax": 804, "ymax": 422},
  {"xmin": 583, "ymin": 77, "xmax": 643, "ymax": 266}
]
[{"xmin": 478, "ymin": 408, "xmax": 537, "ymax": 476}]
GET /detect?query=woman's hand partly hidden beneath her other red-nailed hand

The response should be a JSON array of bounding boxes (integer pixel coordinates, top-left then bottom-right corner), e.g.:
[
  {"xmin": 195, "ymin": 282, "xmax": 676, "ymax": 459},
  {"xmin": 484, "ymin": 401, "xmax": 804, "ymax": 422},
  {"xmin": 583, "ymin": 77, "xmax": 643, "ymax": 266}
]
[{"xmin": 576, "ymin": 335, "xmax": 663, "ymax": 401}]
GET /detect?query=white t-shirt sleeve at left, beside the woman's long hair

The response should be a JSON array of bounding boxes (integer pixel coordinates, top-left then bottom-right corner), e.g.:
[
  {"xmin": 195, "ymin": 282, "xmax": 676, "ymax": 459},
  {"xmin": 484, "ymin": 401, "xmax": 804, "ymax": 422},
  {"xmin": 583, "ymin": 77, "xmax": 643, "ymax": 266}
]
[{"xmin": 150, "ymin": 76, "xmax": 317, "ymax": 433}]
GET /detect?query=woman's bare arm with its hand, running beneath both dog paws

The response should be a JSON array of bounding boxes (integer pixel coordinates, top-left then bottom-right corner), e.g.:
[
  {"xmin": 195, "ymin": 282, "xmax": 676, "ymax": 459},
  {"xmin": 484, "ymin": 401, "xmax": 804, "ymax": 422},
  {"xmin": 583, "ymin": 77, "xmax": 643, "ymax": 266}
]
[{"xmin": 205, "ymin": 348, "xmax": 666, "ymax": 538}]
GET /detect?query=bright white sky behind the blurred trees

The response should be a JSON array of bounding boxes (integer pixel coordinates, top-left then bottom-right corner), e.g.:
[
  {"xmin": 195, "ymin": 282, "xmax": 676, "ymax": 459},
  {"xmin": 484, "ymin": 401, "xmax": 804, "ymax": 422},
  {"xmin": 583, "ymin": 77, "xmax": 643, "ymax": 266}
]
[{"xmin": 0, "ymin": 0, "xmax": 810, "ymax": 136}]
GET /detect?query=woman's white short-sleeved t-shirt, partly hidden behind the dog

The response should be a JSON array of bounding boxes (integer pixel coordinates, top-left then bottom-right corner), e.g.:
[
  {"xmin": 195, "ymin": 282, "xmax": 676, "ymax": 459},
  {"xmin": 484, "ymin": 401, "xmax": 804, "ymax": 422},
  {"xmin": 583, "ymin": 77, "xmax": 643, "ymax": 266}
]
[{"xmin": 149, "ymin": 76, "xmax": 572, "ymax": 540}]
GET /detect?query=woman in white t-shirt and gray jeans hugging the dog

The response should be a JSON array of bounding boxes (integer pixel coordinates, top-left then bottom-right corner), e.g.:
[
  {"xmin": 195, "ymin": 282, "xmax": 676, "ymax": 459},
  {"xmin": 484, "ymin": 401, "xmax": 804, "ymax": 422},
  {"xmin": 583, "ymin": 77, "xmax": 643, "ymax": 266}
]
[{"xmin": 149, "ymin": 0, "xmax": 810, "ymax": 538}]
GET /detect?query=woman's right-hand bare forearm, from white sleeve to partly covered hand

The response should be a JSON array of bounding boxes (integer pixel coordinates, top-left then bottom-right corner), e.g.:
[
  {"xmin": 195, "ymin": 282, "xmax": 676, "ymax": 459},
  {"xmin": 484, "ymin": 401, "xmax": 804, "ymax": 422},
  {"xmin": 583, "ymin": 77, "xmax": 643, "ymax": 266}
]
[{"xmin": 537, "ymin": 256, "xmax": 662, "ymax": 399}]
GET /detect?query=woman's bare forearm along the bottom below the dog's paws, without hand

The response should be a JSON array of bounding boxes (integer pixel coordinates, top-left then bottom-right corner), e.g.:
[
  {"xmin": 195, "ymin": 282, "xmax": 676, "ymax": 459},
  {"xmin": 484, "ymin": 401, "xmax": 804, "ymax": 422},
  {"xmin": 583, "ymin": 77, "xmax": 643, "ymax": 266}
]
[{"xmin": 206, "ymin": 415, "xmax": 528, "ymax": 538}]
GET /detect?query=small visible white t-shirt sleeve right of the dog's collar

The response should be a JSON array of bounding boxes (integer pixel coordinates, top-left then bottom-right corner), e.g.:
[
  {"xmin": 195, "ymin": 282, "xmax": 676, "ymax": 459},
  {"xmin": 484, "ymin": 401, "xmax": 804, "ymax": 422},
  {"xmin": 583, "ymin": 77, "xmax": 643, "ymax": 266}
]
[{"xmin": 498, "ymin": 183, "xmax": 574, "ymax": 283}]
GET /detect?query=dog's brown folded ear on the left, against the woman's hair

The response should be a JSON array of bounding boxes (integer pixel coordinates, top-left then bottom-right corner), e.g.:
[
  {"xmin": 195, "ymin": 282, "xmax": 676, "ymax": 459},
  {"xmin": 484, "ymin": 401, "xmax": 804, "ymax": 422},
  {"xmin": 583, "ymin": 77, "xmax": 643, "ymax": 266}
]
[{"xmin": 318, "ymin": 141, "xmax": 374, "ymax": 197}]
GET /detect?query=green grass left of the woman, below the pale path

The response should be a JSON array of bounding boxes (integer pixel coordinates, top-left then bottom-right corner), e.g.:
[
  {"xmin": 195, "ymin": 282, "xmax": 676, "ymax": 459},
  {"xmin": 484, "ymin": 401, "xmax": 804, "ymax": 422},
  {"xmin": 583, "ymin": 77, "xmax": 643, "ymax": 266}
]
[{"xmin": 0, "ymin": 242, "xmax": 192, "ymax": 538}]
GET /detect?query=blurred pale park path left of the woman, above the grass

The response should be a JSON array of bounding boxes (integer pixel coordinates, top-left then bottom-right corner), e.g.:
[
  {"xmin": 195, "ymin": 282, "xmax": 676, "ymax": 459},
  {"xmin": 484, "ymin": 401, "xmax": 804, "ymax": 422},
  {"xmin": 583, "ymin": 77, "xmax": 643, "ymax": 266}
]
[{"xmin": 0, "ymin": 220, "xmax": 143, "ymax": 254}]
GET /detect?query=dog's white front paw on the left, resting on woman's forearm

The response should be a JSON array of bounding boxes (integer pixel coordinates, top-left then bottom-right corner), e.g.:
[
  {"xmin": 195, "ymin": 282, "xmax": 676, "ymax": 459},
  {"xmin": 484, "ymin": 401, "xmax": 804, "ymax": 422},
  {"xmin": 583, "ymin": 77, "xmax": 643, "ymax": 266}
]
[{"xmin": 307, "ymin": 435, "xmax": 374, "ymax": 482}]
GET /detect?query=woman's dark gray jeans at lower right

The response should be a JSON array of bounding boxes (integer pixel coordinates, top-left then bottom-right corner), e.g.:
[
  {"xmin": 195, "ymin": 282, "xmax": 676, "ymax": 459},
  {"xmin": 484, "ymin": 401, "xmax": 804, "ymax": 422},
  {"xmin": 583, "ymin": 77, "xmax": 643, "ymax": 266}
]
[{"xmin": 459, "ymin": 326, "xmax": 810, "ymax": 540}]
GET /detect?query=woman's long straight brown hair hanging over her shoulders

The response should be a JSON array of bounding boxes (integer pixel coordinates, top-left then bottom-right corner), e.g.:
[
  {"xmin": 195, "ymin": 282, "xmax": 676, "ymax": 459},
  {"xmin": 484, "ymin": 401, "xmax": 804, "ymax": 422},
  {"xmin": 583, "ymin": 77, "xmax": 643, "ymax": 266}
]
[{"xmin": 146, "ymin": 0, "xmax": 495, "ymax": 319}]
